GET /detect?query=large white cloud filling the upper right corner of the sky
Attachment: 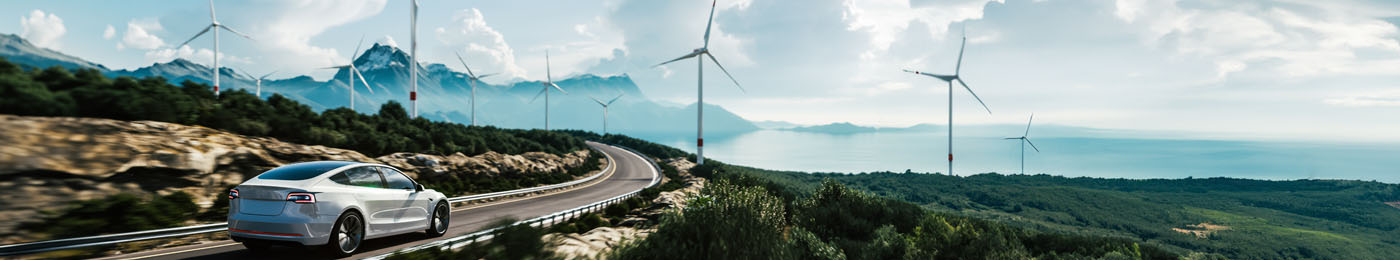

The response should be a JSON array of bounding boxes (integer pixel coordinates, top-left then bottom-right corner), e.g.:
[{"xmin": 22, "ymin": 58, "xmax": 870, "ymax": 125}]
[{"xmin": 1116, "ymin": 0, "xmax": 1400, "ymax": 77}]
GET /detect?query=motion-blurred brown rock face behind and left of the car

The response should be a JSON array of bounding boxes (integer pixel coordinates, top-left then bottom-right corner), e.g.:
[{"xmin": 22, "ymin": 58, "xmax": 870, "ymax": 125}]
[{"xmin": 0, "ymin": 115, "xmax": 377, "ymax": 240}]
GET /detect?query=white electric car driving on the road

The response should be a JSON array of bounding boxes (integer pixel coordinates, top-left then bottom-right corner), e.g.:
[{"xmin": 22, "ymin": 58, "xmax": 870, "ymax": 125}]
[{"xmin": 228, "ymin": 161, "xmax": 452, "ymax": 256}]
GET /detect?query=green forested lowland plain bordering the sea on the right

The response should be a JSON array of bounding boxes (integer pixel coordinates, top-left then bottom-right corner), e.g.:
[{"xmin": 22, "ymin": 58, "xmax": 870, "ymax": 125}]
[{"xmin": 735, "ymin": 168, "xmax": 1400, "ymax": 259}]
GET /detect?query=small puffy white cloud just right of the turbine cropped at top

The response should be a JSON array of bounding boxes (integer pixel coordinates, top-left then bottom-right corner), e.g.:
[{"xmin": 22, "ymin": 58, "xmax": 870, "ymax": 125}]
[{"xmin": 435, "ymin": 8, "xmax": 528, "ymax": 78}]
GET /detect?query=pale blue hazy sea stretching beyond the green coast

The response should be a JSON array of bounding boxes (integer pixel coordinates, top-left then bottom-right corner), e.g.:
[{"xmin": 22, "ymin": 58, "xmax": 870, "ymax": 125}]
[{"xmin": 643, "ymin": 130, "xmax": 1400, "ymax": 183}]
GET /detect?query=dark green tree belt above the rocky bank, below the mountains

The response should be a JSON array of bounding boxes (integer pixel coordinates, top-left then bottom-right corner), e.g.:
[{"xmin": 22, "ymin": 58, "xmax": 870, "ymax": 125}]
[{"xmin": 0, "ymin": 59, "xmax": 587, "ymax": 157}]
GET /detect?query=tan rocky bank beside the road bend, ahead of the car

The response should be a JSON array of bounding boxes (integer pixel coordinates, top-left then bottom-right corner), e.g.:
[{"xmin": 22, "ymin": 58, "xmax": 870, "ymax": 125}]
[{"xmin": 377, "ymin": 150, "xmax": 589, "ymax": 178}]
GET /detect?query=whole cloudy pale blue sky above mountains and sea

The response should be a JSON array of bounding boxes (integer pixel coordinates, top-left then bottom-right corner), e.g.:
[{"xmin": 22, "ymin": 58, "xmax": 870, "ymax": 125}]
[{"xmin": 0, "ymin": 0, "xmax": 1400, "ymax": 141}]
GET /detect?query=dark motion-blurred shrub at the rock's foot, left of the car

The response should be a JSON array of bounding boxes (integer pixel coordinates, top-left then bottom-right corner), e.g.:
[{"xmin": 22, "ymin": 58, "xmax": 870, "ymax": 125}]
[{"xmin": 20, "ymin": 192, "xmax": 205, "ymax": 239}]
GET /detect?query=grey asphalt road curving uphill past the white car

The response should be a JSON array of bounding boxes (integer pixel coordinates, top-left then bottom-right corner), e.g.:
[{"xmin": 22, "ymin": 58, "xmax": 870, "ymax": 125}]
[{"xmin": 104, "ymin": 143, "xmax": 661, "ymax": 259}]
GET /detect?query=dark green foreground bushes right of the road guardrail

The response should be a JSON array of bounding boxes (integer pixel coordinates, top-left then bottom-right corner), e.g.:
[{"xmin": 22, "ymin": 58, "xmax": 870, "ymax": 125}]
[{"xmin": 613, "ymin": 161, "xmax": 1180, "ymax": 259}]
